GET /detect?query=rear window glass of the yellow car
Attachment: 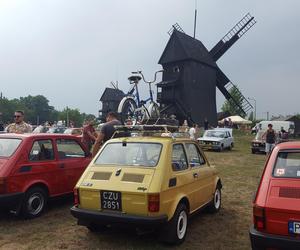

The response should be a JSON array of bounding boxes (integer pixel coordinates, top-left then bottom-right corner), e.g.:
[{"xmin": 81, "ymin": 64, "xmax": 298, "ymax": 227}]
[{"xmin": 95, "ymin": 142, "xmax": 162, "ymax": 167}]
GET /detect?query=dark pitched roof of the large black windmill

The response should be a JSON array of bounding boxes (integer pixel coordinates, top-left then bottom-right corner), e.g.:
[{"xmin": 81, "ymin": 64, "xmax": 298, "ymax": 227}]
[{"xmin": 158, "ymin": 30, "xmax": 217, "ymax": 67}]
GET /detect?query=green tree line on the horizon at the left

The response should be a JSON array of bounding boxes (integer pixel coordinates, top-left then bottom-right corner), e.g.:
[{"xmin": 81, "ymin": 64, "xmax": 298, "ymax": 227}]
[{"xmin": 0, "ymin": 95, "xmax": 95, "ymax": 127}]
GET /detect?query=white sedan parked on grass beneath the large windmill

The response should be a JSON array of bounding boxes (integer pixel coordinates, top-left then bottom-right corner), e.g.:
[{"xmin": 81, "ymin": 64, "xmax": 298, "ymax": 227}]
[{"xmin": 197, "ymin": 128, "xmax": 234, "ymax": 151}]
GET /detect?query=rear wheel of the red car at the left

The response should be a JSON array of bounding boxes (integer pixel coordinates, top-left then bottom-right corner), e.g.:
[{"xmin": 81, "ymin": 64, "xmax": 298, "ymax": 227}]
[{"xmin": 22, "ymin": 187, "xmax": 48, "ymax": 219}]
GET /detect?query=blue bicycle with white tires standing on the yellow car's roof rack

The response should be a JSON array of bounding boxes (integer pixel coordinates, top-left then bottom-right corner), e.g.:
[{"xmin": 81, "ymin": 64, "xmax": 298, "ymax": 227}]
[{"xmin": 118, "ymin": 70, "xmax": 163, "ymax": 125}]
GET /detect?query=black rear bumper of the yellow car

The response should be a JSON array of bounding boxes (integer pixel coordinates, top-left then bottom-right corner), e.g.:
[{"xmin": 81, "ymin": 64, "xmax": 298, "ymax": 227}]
[{"xmin": 71, "ymin": 206, "xmax": 168, "ymax": 227}]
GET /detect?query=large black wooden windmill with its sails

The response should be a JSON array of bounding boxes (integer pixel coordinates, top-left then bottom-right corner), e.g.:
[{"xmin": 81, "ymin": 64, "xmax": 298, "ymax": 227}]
[{"xmin": 157, "ymin": 14, "xmax": 256, "ymax": 125}]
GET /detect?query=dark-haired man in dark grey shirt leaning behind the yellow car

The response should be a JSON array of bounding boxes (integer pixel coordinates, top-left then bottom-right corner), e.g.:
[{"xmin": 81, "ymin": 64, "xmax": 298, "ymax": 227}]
[{"xmin": 92, "ymin": 112, "xmax": 122, "ymax": 157}]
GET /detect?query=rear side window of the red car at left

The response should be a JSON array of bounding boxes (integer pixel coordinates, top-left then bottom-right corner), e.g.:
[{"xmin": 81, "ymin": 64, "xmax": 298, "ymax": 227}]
[{"xmin": 29, "ymin": 140, "xmax": 54, "ymax": 161}]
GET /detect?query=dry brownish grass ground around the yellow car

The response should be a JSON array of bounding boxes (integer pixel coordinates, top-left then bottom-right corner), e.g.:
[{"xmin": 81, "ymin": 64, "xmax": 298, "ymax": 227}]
[{"xmin": 0, "ymin": 131, "xmax": 266, "ymax": 250}]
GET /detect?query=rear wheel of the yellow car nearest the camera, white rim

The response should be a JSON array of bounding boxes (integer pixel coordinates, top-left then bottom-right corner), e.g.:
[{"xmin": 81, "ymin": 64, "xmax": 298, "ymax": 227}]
[{"xmin": 161, "ymin": 203, "xmax": 188, "ymax": 245}]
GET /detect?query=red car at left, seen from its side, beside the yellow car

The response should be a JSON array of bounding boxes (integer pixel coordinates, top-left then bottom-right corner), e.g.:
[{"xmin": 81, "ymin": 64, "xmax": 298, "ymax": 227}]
[{"xmin": 0, "ymin": 134, "xmax": 91, "ymax": 218}]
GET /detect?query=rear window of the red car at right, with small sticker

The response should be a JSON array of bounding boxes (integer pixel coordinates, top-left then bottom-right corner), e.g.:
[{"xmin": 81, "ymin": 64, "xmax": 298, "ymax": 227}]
[{"xmin": 273, "ymin": 152, "xmax": 300, "ymax": 178}]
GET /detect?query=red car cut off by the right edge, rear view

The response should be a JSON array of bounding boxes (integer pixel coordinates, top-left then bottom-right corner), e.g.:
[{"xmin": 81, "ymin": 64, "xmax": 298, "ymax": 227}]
[{"xmin": 250, "ymin": 141, "xmax": 300, "ymax": 249}]
